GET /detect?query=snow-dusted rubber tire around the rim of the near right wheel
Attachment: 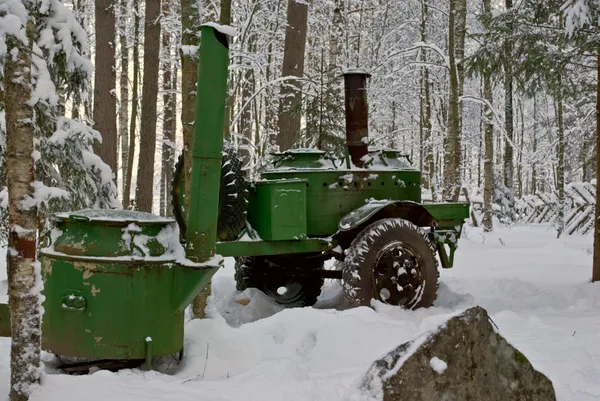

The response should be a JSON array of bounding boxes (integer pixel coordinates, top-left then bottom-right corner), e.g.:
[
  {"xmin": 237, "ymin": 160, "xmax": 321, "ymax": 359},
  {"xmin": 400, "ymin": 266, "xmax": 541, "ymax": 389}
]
[{"xmin": 342, "ymin": 218, "xmax": 439, "ymax": 309}]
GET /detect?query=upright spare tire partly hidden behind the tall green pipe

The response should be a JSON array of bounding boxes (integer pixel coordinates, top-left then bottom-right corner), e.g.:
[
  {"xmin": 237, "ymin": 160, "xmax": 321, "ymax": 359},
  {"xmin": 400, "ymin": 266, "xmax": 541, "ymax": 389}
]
[{"xmin": 171, "ymin": 142, "xmax": 248, "ymax": 241}]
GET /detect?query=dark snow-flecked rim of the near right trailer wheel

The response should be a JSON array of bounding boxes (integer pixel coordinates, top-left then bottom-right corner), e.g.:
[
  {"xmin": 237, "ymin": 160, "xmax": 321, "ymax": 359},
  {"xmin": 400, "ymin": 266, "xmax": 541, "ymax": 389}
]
[{"xmin": 373, "ymin": 241, "xmax": 425, "ymax": 306}]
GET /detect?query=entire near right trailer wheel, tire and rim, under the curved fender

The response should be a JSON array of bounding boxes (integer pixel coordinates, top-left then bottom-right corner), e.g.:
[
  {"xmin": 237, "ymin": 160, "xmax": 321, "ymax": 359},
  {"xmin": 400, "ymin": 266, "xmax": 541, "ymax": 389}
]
[{"xmin": 342, "ymin": 219, "xmax": 439, "ymax": 309}]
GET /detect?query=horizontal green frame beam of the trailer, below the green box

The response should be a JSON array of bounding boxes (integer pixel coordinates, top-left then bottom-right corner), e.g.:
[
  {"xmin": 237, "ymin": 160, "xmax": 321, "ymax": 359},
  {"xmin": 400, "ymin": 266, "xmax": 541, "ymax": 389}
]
[{"xmin": 217, "ymin": 238, "xmax": 336, "ymax": 256}]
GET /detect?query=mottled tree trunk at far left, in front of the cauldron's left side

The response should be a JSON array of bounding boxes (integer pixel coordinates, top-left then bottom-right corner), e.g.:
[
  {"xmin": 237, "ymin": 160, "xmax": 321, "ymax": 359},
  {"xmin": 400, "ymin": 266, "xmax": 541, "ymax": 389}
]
[{"xmin": 4, "ymin": 16, "xmax": 41, "ymax": 401}]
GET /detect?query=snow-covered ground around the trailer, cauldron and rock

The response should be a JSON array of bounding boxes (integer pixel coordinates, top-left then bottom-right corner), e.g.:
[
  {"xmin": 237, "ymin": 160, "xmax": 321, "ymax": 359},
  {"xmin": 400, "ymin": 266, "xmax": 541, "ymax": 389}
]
[{"xmin": 0, "ymin": 226, "xmax": 600, "ymax": 401}]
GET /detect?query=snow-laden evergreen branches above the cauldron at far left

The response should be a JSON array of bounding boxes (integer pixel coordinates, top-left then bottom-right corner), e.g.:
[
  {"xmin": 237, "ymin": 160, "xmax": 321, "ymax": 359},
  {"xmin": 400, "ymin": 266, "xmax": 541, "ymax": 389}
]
[{"xmin": 0, "ymin": 0, "xmax": 120, "ymax": 238}]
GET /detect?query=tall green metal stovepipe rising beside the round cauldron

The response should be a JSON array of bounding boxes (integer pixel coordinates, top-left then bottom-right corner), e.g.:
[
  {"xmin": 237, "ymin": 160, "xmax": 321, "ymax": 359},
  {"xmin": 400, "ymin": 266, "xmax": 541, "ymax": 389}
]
[{"xmin": 186, "ymin": 25, "xmax": 229, "ymax": 262}]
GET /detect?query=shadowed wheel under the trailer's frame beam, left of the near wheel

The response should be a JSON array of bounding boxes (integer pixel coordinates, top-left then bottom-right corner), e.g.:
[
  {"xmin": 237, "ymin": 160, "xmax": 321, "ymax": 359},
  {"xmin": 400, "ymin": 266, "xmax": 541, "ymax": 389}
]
[{"xmin": 235, "ymin": 255, "xmax": 324, "ymax": 308}]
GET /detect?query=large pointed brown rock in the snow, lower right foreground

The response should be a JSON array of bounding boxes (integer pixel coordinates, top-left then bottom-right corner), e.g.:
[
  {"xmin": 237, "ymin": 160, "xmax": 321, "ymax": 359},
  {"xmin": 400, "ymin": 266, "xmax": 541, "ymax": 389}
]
[{"xmin": 362, "ymin": 307, "xmax": 556, "ymax": 401}]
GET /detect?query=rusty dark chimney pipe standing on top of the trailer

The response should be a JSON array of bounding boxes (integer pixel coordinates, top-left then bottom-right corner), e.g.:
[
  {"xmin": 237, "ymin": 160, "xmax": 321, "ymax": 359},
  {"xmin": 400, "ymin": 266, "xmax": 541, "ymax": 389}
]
[{"xmin": 344, "ymin": 72, "xmax": 371, "ymax": 167}]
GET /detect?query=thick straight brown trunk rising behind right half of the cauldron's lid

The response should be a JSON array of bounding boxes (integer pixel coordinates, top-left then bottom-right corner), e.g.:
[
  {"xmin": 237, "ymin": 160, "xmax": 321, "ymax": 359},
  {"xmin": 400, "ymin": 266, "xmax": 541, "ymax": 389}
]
[{"xmin": 135, "ymin": 0, "xmax": 160, "ymax": 213}]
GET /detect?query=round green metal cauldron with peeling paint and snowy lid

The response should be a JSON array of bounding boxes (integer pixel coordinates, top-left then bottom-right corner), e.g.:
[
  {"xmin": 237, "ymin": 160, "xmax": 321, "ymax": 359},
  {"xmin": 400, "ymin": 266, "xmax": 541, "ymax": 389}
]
[{"xmin": 40, "ymin": 210, "xmax": 217, "ymax": 360}]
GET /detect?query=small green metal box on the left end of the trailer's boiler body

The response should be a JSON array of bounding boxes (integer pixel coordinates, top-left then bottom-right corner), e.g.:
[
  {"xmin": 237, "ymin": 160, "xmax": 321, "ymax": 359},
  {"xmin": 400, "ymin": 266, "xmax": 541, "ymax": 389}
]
[{"xmin": 248, "ymin": 179, "xmax": 308, "ymax": 241}]
